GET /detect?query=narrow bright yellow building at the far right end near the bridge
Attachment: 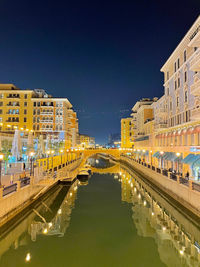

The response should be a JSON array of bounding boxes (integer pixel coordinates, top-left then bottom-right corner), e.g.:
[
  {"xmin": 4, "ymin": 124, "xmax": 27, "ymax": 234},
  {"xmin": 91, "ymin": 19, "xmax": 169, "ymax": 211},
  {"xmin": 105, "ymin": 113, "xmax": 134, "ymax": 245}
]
[{"xmin": 121, "ymin": 117, "xmax": 134, "ymax": 148}]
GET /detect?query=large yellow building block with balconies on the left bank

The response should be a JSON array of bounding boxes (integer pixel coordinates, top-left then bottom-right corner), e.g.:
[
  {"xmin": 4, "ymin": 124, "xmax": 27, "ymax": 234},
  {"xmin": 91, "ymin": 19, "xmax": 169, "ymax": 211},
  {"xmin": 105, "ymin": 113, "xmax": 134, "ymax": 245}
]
[{"xmin": 0, "ymin": 84, "xmax": 78, "ymax": 148}]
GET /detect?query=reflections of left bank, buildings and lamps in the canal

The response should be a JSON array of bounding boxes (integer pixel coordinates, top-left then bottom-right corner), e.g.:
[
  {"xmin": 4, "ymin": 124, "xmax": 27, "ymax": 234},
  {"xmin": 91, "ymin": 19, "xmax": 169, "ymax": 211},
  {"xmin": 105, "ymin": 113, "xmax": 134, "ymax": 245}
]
[{"xmin": 0, "ymin": 180, "xmax": 81, "ymax": 262}]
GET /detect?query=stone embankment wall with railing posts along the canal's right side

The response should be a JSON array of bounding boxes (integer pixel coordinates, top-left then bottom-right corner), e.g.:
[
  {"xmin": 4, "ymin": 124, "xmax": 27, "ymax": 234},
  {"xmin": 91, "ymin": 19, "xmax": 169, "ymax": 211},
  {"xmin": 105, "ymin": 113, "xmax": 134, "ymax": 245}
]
[{"xmin": 120, "ymin": 156, "xmax": 200, "ymax": 220}]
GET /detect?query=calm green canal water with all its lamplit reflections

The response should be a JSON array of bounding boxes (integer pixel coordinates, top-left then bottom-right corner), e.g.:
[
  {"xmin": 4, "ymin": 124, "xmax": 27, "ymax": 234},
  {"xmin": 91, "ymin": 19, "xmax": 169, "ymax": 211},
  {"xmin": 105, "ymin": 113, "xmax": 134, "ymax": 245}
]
[{"xmin": 0, "ymin": 163, "xmax": 200, "ymax": 267}]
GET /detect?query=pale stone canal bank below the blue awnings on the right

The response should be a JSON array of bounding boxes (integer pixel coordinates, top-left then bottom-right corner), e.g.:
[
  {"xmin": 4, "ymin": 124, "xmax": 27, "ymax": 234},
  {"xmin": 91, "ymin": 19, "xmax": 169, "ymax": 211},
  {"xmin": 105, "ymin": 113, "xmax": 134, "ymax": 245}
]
[{"xmin": 120, "ymin": 156, "xmax": 200, "ymax": 224}]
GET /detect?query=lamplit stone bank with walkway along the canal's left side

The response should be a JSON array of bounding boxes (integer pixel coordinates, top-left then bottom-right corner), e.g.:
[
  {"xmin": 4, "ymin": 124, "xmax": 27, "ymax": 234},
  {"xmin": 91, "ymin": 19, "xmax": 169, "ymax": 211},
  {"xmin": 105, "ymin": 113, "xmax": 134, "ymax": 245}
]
[{"xmin": 0, "ymin": 159, "xmax": 82, "ymax": 229}]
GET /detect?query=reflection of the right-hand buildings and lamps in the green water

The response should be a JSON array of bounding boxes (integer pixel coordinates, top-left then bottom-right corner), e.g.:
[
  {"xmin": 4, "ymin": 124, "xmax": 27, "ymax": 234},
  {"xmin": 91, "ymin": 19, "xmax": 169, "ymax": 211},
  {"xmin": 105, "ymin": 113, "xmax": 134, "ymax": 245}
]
[{"xmin": 119, "ymin": 170, "xmax": 200, "ymax": 267}]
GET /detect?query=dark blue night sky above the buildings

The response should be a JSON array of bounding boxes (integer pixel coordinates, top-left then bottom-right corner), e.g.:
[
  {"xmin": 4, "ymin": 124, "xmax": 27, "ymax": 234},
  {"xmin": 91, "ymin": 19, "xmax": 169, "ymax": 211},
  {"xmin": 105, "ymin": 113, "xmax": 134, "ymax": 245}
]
[{"xmin": 0, "ymin": 0, "xmax": 200, "ymax": 143}]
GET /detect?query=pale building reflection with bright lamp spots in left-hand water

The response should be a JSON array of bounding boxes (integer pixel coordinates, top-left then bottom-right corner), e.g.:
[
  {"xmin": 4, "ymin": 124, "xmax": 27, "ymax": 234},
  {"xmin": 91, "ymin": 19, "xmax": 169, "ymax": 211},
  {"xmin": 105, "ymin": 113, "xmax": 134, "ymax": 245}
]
[{"xmin": 30, "ymin": 180, "xmax": 79, "ymax": 241}]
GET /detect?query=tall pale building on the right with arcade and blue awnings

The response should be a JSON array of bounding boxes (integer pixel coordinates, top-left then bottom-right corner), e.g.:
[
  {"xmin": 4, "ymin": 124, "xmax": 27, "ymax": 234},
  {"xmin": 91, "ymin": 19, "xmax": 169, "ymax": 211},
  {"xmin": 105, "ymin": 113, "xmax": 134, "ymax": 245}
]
[{"xmin": 130, "ymin": 17, "xmax": 200, "ymax": 179}]
